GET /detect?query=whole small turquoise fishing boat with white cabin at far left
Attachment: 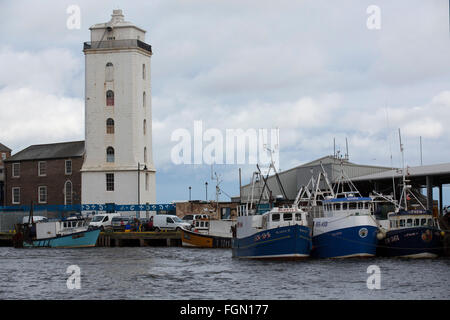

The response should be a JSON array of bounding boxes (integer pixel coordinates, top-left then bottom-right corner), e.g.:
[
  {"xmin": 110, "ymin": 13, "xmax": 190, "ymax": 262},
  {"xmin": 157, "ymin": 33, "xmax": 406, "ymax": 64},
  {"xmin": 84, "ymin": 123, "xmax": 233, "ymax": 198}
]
[{"xmin": 15, "ymin": 212, "xmax": 100, "ymax": 248}]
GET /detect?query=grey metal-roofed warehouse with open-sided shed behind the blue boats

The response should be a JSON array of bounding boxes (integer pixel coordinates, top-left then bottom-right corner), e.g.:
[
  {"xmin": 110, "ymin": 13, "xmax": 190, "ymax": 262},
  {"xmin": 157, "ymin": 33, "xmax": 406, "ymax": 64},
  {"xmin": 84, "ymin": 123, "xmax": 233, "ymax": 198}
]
[{"xmin": 241, "ymin": 156, "xmax": 450, "ymax": 215}]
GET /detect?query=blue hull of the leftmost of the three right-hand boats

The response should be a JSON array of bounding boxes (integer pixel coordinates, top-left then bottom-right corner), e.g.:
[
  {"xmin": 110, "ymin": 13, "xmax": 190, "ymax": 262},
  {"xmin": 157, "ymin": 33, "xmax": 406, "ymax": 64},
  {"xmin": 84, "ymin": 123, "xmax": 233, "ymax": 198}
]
[{"xmin": 232, "ymin": 225, "xmax": 312, "ymax": 260}]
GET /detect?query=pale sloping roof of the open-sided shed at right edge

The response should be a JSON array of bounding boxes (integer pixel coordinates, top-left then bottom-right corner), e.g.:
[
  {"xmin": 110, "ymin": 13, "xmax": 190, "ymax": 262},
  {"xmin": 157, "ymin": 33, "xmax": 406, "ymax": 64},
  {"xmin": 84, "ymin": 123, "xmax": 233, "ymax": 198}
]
[{"xmin": 352, "ymin": 163, "xmax": 450, "ymax": 181}]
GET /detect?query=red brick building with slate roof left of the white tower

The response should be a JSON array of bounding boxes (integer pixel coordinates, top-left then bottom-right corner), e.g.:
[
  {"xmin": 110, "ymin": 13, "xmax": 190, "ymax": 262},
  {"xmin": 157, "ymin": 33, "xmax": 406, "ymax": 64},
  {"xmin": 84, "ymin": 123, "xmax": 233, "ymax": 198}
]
[{"xmin": 4, "ymin": 141, "xmax": 84, "ymax": 206}]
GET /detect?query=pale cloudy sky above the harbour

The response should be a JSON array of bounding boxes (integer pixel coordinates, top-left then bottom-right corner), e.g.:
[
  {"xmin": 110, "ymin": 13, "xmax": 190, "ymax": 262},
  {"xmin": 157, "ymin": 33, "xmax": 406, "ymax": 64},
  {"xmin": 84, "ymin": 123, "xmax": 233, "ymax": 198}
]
[{"xmin": 0, "ymin": 0, "xmax": 450, "ymax": 203}]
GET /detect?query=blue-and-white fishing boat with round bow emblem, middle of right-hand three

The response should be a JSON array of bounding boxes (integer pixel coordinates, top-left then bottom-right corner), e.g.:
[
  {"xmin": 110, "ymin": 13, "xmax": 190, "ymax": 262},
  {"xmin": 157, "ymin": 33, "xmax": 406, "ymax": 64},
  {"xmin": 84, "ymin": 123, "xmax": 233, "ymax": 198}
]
[{"xmin": 311, "ymin": 166, "xmax": 380, "ymax": 258}]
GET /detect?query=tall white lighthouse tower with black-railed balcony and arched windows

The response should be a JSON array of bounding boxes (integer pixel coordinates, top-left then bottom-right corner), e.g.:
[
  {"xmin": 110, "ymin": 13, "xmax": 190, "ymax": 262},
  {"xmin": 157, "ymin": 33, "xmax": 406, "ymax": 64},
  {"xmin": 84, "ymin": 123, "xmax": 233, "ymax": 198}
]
[{"xmin": 81, "ymin": 10, "xmax": 156, "ymax": 215}]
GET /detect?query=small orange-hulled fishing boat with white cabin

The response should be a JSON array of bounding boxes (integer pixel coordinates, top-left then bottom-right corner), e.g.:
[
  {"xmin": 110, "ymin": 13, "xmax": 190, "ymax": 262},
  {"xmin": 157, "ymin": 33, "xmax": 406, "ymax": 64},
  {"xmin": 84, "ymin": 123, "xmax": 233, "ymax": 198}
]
[{"xmin": 181, "ymin": 218, "xmax": 234, "ymax": 248}]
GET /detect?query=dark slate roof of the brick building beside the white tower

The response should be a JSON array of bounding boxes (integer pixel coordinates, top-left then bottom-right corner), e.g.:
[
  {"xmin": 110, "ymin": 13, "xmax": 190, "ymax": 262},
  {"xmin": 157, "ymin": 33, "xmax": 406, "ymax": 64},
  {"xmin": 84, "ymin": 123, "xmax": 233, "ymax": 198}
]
[{"xmin": 5, "ymin": 141, "xmax": 84, "ymax": 162}]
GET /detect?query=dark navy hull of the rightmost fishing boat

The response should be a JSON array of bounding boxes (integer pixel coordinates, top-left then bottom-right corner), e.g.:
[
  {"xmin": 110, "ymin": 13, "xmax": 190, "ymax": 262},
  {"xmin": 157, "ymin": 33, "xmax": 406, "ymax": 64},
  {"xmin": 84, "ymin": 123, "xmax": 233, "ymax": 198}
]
[{"xmin": 377, "ymin": 227, "xmax": 442, "ymax": 258}]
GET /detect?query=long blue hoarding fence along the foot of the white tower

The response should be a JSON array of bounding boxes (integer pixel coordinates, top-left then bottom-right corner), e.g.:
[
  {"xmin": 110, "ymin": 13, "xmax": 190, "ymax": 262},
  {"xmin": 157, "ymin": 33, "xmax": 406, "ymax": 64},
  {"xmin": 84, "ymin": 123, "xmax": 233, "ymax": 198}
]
[{"xmin": 0, "ymin": 203, "xmax": 175, "ymax": 212}]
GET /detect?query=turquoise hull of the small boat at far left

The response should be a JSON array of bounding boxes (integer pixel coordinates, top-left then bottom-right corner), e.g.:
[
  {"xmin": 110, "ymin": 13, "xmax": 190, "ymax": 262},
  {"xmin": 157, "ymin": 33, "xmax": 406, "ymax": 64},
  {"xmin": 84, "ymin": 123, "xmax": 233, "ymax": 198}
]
[{"xmin": 23, "ymin": 229, "xmax": 100, "ymax": 248}]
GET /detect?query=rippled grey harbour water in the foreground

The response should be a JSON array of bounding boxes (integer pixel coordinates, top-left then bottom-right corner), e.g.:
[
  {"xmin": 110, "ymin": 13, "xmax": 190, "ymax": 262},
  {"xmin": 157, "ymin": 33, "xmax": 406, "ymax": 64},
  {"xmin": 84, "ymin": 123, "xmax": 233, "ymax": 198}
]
[{"xmin": 0, "ymin": 247, "xmax": 450, "ymax": 300}]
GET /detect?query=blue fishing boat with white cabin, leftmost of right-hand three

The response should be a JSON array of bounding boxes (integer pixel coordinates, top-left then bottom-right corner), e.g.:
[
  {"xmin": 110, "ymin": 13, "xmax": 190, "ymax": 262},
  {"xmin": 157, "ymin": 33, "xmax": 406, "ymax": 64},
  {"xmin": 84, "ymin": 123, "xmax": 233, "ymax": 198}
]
[{"xmin": 232, "ymin": 162, "xmax": 312, "ymax": 260}]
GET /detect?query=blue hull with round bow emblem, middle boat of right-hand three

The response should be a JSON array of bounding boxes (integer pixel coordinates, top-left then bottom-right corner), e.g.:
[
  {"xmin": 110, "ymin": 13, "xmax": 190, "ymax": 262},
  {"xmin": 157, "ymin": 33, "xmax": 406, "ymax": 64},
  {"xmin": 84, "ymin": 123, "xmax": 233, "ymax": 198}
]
[{"xmin": 312, "ymin": 225, "xmax": 378, "ymax": 258}]
